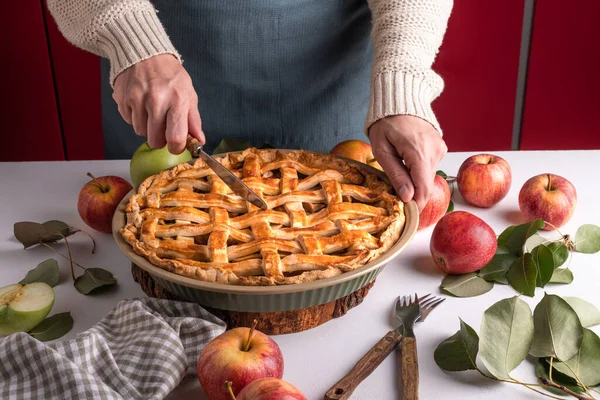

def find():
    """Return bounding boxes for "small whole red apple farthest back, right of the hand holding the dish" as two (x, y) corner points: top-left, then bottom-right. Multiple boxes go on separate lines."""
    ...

(456, 154), (512, 207)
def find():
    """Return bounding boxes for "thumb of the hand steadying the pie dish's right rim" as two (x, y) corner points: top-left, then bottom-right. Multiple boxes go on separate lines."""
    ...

(373, 139), (414, 203)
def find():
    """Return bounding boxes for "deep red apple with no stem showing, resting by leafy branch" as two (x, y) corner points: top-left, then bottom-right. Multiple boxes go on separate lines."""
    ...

(429, 211), (498, 274)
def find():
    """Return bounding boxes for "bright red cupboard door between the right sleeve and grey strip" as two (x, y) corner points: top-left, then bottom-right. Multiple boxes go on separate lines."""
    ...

(433, 0), (525, 151)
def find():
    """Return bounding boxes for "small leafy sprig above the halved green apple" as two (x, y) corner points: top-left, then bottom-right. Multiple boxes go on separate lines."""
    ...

(14, 220), (117, 294)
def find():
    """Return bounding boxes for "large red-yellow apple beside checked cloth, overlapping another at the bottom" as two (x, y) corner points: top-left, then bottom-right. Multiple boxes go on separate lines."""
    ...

(198, 327), (283, 400)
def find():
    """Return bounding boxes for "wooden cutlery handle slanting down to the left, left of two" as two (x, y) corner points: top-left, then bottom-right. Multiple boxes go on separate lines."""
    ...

(325, 331), (402, 400)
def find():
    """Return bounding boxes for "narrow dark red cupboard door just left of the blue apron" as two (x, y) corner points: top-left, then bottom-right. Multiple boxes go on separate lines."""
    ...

(44, 5), (104, 160)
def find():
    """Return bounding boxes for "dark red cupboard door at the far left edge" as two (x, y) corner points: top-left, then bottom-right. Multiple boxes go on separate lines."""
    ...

(0, 0), (65, 161)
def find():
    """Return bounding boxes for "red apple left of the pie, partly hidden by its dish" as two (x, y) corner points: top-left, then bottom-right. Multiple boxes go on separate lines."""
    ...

(77, 172), (133, 233)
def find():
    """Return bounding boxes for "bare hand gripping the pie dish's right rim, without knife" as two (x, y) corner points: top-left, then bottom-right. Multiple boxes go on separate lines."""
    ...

(369, 115), (448, 211)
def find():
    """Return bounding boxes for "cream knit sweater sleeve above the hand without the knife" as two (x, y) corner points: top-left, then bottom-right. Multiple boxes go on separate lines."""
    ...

(365, 0), (452, 134)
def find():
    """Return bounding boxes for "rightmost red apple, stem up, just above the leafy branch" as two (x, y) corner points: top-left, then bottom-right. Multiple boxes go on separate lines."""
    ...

(519, 174), (577, 230)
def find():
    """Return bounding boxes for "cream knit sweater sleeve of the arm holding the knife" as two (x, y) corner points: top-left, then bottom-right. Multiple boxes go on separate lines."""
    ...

(47, 0), (181, 84)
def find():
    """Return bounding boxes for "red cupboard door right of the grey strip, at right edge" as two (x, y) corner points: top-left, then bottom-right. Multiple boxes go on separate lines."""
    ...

(521, 0), (600, 150)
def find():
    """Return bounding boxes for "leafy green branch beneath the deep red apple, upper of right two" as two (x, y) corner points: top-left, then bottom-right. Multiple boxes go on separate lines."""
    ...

(441, 219), (600, 297)
